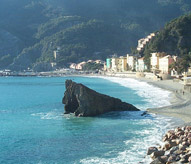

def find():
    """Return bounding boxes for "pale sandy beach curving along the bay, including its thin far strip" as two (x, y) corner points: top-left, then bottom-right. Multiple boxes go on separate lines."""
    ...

(85, 75), (191, 126)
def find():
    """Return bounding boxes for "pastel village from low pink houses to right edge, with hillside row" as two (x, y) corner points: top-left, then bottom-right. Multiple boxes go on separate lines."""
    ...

(70, 33), (191, 92)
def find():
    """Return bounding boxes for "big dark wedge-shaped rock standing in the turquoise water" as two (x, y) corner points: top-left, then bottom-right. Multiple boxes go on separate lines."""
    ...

(62, 80), (139, 117)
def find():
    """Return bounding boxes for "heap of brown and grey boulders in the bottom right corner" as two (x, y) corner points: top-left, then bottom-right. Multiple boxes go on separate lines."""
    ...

(147, 126), (191, 164)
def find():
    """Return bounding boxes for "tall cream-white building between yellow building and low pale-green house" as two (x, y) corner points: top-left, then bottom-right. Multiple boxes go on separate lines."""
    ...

(127, 54), (139, 71)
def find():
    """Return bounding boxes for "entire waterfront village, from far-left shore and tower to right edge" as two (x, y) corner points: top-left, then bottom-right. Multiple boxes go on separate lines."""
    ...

(0, 33), (191, 92)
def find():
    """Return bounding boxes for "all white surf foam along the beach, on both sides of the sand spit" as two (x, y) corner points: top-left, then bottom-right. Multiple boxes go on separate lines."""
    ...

(80, 77), (173, 164)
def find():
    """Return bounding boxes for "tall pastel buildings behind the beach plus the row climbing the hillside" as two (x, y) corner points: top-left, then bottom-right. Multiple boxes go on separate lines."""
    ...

(104, 33), (178, 80)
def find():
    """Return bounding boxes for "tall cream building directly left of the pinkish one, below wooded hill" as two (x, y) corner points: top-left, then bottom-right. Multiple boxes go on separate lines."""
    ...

(150, 52), (166, 72)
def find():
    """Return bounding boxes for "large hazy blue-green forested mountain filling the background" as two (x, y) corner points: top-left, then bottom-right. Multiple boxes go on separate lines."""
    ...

(0, 0), (191, 69)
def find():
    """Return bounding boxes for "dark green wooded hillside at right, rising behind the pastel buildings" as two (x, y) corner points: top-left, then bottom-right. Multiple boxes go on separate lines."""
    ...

(144, 14), (191, 66)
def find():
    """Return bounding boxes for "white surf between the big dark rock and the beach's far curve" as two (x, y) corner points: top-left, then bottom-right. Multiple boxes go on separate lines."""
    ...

(95, 77), (171, 110)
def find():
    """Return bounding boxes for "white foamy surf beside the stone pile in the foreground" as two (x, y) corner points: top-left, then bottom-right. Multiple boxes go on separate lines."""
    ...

(80, 116), (175, 164)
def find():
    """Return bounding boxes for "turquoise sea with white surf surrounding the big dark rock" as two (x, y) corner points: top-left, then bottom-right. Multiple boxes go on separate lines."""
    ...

(0, 76), (176, 164)
